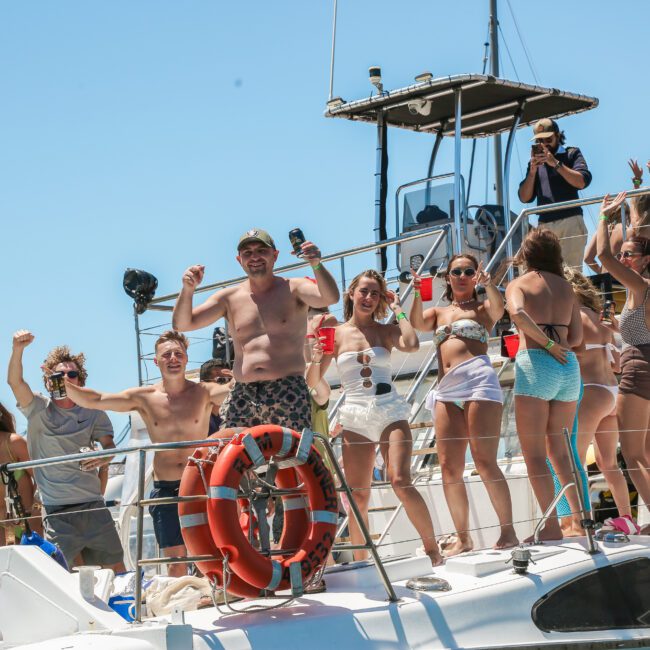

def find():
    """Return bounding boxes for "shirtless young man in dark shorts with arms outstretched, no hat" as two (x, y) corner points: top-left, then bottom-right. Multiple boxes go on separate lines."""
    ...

(66, 331), (228, 576)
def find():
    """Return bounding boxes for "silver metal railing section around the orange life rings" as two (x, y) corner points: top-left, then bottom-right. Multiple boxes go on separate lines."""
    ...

(0, 430), (398, 622)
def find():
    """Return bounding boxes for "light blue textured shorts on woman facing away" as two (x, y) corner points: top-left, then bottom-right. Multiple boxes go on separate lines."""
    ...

(515, 350), (580, 402)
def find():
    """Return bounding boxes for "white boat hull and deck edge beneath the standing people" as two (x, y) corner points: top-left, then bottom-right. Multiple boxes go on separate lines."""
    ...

(5, 537), (650, 650)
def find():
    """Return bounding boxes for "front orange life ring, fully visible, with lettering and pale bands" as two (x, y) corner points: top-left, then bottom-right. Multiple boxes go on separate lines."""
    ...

(207, 424), (338, 591)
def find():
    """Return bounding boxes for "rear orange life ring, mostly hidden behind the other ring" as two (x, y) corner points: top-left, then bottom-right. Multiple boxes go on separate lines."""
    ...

(178, 429), (260, 598)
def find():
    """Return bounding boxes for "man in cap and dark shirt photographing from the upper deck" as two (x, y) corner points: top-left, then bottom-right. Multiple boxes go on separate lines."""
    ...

(519, 118), (591, 271)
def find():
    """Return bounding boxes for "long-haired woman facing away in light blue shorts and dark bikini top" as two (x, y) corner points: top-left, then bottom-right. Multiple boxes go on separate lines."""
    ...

(506, 228), (582, 540)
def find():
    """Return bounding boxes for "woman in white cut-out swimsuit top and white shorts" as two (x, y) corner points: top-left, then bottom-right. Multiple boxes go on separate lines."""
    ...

(307, 270), (443, 566)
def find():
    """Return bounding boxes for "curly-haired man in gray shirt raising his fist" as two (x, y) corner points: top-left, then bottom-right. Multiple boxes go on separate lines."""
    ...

(8, 330), (125, 572)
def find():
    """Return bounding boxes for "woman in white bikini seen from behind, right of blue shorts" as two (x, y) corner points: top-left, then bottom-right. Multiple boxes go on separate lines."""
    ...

(565, 269), (638, 532)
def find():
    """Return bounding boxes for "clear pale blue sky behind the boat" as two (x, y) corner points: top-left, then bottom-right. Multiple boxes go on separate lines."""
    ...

(0, 0), (650, 436)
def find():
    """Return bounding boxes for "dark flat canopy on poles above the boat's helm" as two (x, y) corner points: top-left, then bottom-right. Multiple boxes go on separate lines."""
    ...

(325, 74), (598, 138)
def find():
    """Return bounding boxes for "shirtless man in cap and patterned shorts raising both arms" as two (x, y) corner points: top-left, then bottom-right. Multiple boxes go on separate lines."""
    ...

(172, 229), (339, 431)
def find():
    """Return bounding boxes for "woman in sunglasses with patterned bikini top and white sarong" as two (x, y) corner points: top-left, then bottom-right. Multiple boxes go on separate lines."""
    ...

(411, 255), (518, 557)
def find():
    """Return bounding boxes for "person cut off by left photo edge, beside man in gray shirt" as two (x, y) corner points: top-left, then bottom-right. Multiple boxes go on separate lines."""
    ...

(0, 404), (43, 546)
